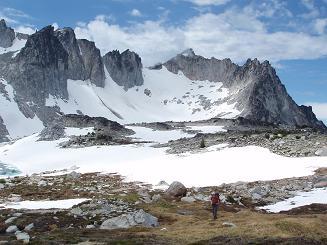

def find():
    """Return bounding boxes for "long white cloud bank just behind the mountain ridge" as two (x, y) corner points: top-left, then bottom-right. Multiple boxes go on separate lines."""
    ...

(75, 8), (327, 65)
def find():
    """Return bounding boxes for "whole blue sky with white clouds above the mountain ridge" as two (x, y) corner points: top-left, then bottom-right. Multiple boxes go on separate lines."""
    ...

(0, 0), (327, 122)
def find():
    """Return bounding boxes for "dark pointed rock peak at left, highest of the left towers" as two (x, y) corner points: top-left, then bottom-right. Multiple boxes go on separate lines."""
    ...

(2, 26), (68, 104)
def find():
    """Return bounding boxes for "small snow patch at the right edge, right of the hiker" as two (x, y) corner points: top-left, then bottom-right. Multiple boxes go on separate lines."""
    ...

(260, 188), (327, 213)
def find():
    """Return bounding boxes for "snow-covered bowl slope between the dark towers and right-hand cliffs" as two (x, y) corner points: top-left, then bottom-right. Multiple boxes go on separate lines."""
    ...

(46, 68), (240, 123)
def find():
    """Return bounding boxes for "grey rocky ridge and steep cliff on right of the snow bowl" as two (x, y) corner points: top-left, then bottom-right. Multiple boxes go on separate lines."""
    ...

(163, 50), (324, 128)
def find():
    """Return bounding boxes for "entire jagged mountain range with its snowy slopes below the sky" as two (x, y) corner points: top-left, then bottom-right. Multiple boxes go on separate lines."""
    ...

(0, 20), (325, 140)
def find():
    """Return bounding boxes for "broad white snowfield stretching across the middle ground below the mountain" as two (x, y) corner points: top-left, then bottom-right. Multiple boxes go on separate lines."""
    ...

(0, 127), (327, 187)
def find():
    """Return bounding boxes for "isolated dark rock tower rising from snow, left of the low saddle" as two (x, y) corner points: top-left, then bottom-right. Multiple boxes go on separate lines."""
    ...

(103, 50), (144, 90)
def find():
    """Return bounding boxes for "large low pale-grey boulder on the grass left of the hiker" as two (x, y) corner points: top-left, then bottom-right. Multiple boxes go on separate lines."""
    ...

(100, 209), (159, 230)
